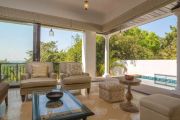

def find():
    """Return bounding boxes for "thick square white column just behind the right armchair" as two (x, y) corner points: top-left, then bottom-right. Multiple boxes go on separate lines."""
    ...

(82, 31), (96, 77)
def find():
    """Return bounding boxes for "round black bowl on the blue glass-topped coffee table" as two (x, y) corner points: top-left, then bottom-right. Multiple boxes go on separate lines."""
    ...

(46, 91), (63, 101)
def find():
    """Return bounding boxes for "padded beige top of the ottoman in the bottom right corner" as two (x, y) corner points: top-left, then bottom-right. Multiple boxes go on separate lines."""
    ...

(140, 94), (180, 118)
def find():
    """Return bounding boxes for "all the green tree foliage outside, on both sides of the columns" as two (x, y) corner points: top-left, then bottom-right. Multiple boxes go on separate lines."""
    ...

(24, 26), (177, 76)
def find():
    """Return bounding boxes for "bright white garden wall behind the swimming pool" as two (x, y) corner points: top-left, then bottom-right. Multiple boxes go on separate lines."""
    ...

(127, 60), (177, 76)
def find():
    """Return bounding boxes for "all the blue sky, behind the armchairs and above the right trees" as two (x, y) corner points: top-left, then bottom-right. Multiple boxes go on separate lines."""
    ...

(0, 16), (177, 61)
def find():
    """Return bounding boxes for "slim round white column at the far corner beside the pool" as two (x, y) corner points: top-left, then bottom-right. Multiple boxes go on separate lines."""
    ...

(103, 35), (110, 77)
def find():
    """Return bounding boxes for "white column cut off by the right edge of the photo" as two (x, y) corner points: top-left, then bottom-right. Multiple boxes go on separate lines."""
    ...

(174, 8), (180, 90)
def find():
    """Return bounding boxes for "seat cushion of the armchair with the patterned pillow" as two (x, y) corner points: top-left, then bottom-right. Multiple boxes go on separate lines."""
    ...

(61, 75), (91, 85)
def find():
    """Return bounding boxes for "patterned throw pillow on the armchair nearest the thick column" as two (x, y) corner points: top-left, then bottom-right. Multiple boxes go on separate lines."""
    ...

(67, 63), (82, 75)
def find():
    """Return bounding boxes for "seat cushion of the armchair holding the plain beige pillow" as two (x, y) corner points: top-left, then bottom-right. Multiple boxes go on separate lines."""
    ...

(20, 78), (57, 88)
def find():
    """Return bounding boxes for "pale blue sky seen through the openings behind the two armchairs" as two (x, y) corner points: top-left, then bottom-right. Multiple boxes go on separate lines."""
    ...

(0, 22), (83, 61)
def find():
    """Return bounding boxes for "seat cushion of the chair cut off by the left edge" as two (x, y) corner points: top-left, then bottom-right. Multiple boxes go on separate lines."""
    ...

(0, 82), (9, 101)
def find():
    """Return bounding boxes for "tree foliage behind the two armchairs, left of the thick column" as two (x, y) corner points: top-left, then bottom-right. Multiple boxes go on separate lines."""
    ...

(26, 35), (82, 63)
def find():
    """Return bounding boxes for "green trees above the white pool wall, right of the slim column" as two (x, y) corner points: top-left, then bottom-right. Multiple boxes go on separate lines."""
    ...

(105, 26), (177, 75)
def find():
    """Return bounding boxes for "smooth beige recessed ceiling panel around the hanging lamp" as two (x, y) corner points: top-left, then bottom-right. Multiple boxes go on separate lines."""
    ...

(0, 0), (146, 25)
